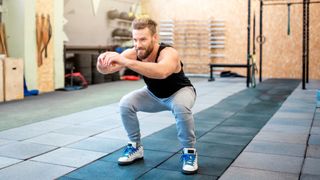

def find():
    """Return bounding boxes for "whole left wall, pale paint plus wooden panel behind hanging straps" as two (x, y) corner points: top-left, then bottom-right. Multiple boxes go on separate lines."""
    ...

(3, 0), (64, 93)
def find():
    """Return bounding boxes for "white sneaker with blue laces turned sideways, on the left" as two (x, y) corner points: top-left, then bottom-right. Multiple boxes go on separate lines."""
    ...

(118, 142), (143, 165)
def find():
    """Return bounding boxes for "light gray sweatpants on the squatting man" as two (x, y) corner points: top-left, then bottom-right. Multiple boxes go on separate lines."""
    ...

(120, 86), (196, 148)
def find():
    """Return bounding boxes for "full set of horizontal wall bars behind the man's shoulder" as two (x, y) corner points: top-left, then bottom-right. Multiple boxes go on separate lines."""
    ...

(159, 19), (225, 74)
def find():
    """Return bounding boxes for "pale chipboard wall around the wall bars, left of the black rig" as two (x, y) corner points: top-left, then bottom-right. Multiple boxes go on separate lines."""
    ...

(141, 0), (247, 74)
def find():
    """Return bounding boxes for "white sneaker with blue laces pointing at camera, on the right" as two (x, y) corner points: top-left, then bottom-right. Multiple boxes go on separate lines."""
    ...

(181, 148), (198, 174)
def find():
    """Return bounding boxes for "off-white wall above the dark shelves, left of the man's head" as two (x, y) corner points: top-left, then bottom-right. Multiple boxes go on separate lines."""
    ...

(64, 0), (138, 46)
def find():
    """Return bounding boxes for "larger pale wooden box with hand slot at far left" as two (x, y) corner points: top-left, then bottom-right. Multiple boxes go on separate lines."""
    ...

(3, 58), (24, 101)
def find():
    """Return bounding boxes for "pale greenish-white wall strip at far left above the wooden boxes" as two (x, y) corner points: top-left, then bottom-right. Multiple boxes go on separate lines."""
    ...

(3, 0), (37, 89)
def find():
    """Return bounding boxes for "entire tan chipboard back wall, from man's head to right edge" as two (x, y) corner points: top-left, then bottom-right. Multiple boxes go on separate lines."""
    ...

(141, 0), (320, 79)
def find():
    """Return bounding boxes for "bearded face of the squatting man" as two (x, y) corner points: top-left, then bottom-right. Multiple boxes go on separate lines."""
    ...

(132, 28), (155, 59)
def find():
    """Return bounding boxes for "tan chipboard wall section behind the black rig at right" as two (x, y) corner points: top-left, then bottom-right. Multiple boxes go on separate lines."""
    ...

(256, 1), (320, 79)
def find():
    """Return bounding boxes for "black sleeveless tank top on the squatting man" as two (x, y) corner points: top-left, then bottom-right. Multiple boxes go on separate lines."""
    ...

(138, 43), (192, 98)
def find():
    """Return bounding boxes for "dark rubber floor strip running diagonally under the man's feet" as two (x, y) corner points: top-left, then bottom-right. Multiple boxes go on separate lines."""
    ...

(59, 79), (299, 179)
